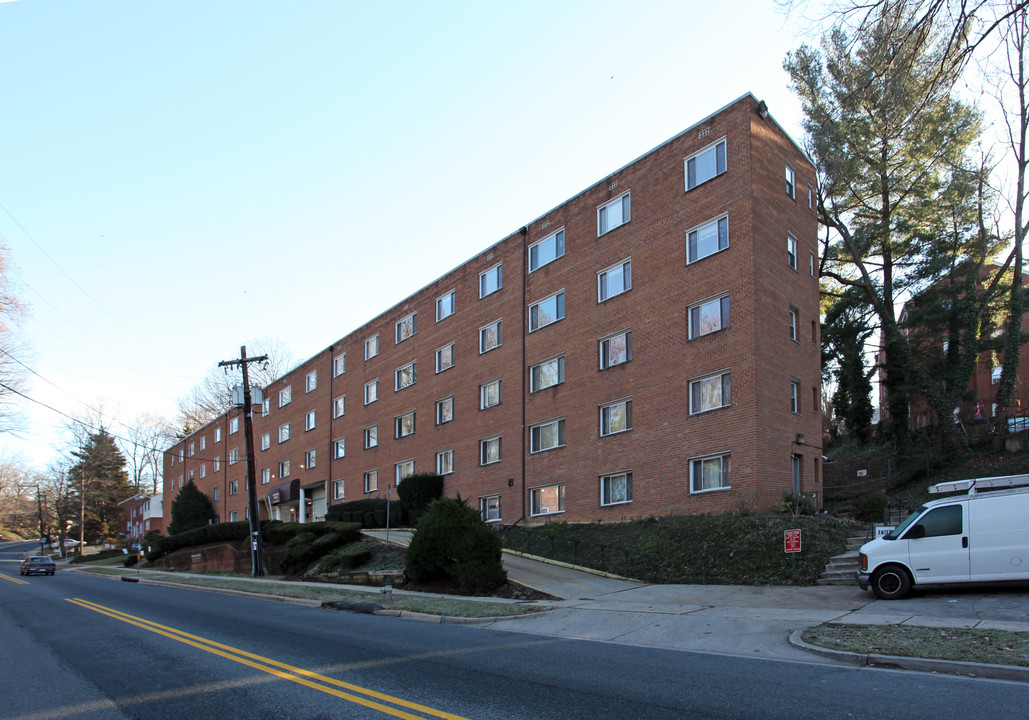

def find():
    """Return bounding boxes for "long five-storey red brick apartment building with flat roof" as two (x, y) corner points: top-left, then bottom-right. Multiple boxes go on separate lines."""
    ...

(165, 94), (822, 524)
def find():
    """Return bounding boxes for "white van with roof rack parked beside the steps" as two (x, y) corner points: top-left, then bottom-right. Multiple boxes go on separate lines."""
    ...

(857, 474), (1029, 600)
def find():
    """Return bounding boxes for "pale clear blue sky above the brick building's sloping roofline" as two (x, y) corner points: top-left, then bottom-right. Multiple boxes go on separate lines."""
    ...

(0, 0), (812, 467)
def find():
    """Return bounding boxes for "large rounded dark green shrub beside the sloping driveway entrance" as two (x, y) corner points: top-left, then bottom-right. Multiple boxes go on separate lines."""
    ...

(404, 495), (507, 590)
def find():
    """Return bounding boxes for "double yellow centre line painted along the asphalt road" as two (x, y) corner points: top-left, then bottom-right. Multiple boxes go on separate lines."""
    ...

(68, 596), (473, 720)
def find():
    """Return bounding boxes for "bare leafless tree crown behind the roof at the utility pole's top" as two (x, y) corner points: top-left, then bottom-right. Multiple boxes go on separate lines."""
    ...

(175, 337), (296, 436)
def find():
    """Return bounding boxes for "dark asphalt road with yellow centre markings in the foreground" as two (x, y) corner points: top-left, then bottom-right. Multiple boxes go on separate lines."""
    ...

(0, 544), (1029, 720)
